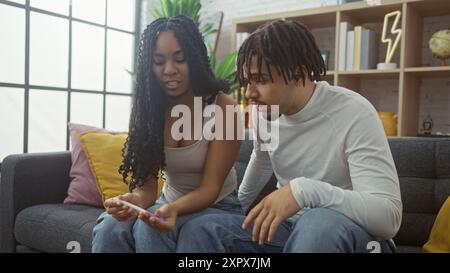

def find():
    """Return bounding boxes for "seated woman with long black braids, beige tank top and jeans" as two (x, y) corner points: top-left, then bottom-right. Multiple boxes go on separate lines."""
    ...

(92, 16), (241, 252)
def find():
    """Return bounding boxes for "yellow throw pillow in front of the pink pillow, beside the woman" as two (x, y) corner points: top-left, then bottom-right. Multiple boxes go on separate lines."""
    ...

(80, 132), (163, 205)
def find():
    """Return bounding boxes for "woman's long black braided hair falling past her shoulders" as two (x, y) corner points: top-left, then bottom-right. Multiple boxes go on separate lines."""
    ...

(119, 15), (229, 191)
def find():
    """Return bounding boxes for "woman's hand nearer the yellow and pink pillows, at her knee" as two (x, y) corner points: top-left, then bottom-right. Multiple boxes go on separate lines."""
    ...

(105, 193), (140, 221)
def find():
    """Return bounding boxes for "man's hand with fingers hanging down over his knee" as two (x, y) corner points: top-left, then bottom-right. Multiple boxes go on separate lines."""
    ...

(242, 184), (300, 245)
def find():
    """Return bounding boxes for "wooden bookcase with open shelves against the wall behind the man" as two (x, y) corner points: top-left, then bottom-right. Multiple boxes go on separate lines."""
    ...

(231, 0), (450, 137)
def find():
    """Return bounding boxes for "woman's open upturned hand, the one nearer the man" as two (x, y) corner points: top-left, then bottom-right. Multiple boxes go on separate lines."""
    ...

(138, 204), (178, 233)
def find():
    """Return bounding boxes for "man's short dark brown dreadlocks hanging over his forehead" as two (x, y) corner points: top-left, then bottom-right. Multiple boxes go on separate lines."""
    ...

(236, 20), (326, 86)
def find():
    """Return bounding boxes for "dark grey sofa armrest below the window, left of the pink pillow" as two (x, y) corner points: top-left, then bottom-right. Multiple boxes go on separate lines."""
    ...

(0, 152), (71, 252)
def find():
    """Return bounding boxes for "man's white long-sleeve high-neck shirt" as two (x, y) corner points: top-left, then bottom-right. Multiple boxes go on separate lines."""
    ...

(239, 82), (402, 239)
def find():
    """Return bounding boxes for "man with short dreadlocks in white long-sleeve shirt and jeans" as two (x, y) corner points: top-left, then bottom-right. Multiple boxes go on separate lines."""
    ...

(179, 20), (402, 252)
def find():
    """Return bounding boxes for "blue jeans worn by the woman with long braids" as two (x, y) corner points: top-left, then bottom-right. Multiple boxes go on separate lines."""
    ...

(92, 192), (242, 253)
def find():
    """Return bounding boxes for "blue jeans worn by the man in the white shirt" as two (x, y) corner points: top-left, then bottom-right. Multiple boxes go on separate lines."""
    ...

(177, 208), (391, 253)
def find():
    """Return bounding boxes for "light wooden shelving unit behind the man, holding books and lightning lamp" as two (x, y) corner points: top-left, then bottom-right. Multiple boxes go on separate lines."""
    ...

(231, 0), (450, 136)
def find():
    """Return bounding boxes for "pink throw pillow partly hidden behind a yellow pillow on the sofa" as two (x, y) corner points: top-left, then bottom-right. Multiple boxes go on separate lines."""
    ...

(64, 122), (113, 207)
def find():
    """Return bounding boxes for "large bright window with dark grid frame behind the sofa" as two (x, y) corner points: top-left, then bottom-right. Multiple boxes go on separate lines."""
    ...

(0, 0), (141, 162)
